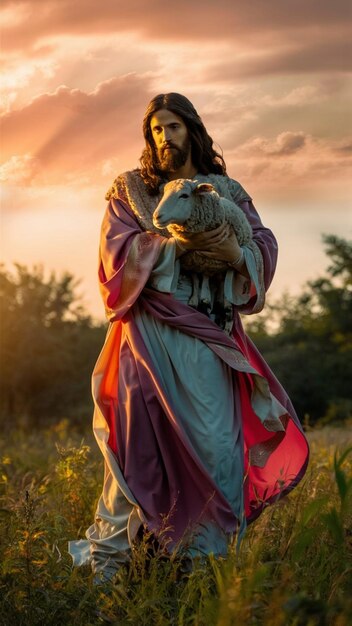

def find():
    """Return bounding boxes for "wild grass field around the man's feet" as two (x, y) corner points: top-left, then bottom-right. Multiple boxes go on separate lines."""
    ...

(0, 421), (352, 626)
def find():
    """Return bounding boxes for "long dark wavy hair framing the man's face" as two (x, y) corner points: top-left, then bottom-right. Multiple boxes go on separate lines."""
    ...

(140, 93), (226, 195)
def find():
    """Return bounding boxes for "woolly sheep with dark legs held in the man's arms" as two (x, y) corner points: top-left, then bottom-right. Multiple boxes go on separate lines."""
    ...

(153, 179), (252, 327)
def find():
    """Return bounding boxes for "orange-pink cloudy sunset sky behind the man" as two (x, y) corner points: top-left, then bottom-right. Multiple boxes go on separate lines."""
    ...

(0, 0), (352, 319)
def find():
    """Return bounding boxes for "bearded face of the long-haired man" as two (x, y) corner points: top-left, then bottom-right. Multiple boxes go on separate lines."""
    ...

(150, 109), (191, 172)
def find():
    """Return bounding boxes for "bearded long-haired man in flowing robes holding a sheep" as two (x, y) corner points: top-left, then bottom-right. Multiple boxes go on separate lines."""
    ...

(70, 93), (308, 576)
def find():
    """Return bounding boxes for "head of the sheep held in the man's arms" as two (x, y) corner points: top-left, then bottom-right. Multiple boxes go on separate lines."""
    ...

(153, 178), (217, 228)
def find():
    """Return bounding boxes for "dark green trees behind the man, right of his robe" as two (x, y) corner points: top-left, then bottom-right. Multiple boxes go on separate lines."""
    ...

(246, 235), (352, 424)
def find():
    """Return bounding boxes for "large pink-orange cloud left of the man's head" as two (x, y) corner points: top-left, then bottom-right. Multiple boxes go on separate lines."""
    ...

(2, 75), (151, 184)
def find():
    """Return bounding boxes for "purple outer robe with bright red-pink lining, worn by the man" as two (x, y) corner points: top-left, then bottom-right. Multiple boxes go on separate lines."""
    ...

(89, 184), (308, 545)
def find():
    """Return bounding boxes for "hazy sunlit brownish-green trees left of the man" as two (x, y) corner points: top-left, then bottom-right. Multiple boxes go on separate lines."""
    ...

(0, 264), (104, 426)
